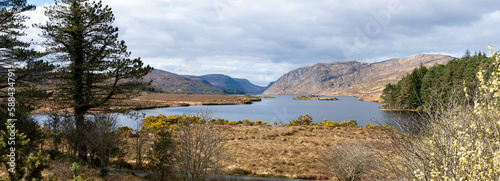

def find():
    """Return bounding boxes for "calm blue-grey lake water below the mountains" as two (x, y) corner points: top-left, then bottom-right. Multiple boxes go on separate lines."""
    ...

(35, 95), (398, 127)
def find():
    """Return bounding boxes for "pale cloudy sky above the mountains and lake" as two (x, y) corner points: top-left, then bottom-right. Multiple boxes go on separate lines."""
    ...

(26, 0), (500, 86)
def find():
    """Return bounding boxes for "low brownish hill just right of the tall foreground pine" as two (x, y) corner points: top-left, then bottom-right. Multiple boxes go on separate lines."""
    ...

(144, 70), (224, 94)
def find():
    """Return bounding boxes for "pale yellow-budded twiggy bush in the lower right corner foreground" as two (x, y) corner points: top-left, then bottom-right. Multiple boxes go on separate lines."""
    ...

(384, 47), (500, 180)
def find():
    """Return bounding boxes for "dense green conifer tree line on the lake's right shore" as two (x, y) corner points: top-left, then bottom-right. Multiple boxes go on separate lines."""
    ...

(381, 50), (493, 110)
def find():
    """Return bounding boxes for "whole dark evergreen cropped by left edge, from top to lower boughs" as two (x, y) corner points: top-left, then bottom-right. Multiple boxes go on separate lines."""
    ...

(0, 0), (53, 146)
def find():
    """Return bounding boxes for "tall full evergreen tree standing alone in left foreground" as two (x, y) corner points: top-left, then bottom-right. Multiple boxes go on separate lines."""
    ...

(38, 0), (152, 159)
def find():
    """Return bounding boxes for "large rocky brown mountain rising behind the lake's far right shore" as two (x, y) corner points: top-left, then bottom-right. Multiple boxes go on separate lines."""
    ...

(263, 54), (454, 99)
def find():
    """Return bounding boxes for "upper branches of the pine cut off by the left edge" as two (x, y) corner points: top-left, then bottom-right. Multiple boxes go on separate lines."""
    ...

(0, 0), (53, 95)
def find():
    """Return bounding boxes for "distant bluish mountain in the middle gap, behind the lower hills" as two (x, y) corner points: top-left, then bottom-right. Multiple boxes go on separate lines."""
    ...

(200, 74), (266, 94)
